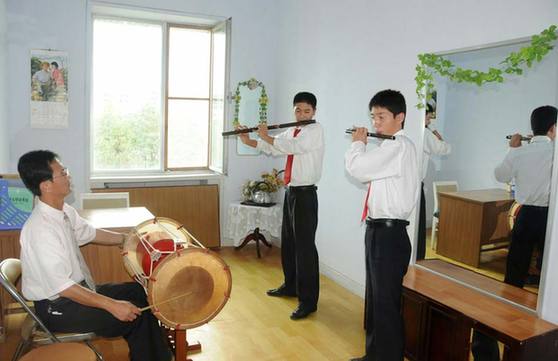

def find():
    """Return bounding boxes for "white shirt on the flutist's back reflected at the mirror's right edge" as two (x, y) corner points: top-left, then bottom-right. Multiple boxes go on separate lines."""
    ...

(494, 135), (554, 207)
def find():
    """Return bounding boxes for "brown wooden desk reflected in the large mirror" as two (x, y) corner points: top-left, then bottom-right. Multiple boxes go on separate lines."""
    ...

(436, 189), (513, 267)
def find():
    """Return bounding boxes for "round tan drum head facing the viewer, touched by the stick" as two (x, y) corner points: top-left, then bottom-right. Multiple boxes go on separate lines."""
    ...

(147, 248), (232, 329)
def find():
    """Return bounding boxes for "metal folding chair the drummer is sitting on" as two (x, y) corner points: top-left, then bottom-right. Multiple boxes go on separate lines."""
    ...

(0, 258), (103, 361)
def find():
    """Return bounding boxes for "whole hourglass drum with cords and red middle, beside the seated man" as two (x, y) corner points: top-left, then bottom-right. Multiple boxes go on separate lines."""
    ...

(122, 217), (232, 329)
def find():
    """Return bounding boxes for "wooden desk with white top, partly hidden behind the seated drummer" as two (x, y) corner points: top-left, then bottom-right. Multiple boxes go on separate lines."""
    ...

(0, 207), (154, 342)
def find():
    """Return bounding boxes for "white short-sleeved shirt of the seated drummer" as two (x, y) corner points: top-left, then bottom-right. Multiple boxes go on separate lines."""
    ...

(20, 199), (96, 301)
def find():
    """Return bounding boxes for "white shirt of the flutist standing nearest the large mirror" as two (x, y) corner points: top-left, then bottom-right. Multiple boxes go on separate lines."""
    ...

(345, 130), (419, 219)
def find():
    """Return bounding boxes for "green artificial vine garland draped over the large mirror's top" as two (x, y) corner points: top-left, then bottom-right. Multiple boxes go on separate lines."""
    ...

(415, 25), (557, 109)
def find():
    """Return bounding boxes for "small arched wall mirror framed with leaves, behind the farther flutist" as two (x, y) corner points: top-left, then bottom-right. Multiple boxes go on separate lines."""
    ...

(233, 78), (268, 155)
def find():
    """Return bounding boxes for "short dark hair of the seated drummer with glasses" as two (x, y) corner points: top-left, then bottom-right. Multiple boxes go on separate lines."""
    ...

(17, 150), (58, 196)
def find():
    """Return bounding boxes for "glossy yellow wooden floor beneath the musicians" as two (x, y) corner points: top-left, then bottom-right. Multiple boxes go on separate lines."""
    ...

(0, 245), (376, 361)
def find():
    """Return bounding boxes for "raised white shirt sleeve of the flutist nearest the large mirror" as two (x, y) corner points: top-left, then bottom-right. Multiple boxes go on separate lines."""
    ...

(345, 140), (404, 182)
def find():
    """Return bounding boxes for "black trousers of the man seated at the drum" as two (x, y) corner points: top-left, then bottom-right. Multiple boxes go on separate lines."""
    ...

(35, 282), (172, 361)
